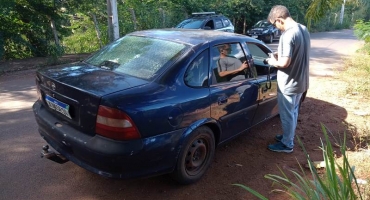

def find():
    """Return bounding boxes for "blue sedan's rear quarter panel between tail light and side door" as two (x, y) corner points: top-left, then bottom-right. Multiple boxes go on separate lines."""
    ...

(101, 44), (210, 138)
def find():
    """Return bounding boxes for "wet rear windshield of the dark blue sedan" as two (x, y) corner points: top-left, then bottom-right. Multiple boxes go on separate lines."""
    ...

(86, 36), (187, 79)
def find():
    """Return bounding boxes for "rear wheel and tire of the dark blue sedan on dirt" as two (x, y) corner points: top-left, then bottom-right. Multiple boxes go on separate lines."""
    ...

(171, 126), (216, 184)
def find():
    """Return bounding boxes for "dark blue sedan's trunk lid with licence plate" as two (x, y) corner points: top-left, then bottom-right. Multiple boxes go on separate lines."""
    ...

(36, 63), (148, 135)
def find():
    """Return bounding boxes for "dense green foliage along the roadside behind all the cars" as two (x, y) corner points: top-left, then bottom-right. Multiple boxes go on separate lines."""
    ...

(0, 0), (370, 60)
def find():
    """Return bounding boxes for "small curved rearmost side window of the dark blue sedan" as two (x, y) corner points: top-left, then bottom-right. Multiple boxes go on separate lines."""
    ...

(184, 50), (209, 87)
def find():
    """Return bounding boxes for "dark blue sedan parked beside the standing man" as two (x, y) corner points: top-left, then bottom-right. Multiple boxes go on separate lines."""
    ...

(33, 29), (278, 184)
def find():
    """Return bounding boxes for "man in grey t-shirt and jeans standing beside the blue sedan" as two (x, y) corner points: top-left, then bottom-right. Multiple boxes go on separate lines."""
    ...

(267, 5), (311, 153)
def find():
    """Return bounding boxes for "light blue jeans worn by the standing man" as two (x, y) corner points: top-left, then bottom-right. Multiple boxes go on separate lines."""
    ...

(277, 90), (302, 148)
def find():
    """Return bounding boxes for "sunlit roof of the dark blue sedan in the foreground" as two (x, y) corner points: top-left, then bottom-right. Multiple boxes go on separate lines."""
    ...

(128, 28), (259, 46)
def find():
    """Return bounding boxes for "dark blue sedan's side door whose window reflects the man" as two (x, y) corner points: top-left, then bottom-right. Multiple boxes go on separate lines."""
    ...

(210, 43), (258, 141)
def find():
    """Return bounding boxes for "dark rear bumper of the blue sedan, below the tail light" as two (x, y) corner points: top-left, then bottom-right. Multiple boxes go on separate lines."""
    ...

(33, 101), (184, 179)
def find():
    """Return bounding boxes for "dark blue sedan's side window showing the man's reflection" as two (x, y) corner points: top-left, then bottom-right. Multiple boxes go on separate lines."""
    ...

(211, 43), (248, 84)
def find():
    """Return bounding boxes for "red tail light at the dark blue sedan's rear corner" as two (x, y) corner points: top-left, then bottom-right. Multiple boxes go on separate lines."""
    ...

(95, 106), (141, 140)
